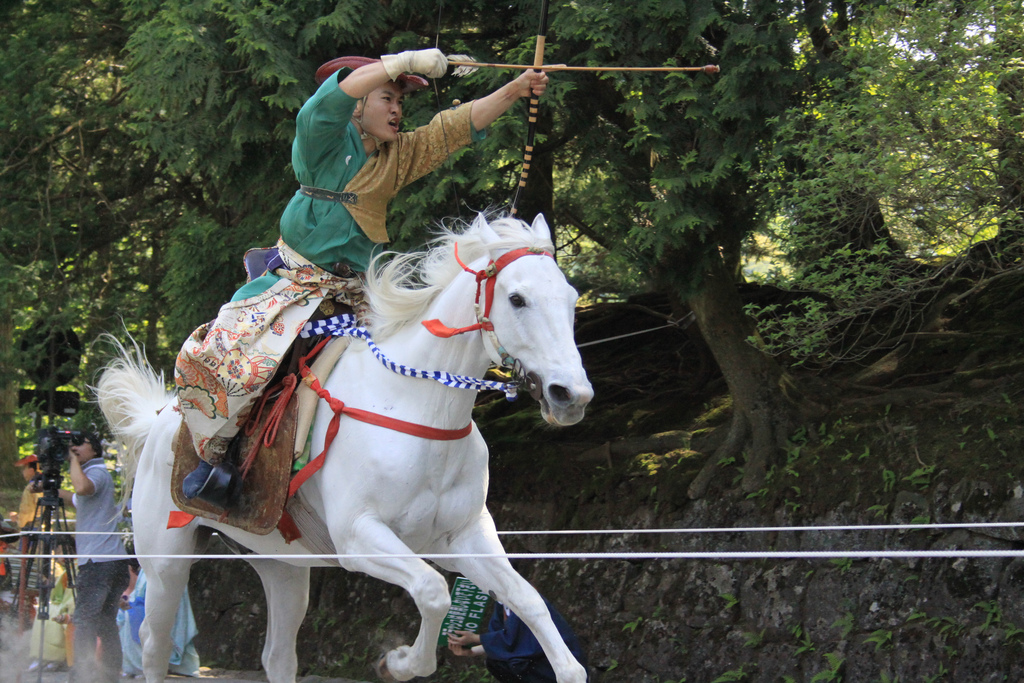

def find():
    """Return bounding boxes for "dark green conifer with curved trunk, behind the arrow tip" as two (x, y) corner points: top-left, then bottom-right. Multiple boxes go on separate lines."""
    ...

(554, 1), (813, 497)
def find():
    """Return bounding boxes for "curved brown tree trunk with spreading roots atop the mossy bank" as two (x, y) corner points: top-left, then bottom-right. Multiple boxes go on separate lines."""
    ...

(687, 254), (803, 499)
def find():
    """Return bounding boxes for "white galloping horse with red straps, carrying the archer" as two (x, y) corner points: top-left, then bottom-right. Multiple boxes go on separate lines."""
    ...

(96, 216), (593, 683)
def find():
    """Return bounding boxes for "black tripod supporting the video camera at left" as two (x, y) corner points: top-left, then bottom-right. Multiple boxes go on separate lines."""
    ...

(16, 480), (76, 681)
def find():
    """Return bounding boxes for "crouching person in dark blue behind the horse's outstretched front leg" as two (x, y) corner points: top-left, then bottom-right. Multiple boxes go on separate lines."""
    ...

(449, 596), (589, 683)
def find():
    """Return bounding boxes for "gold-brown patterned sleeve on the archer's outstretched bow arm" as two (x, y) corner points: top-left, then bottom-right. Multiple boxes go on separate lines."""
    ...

(395, 102), (473, 190)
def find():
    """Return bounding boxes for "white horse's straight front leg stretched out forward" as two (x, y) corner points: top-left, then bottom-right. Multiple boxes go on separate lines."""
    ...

(437, 511), (587, 683)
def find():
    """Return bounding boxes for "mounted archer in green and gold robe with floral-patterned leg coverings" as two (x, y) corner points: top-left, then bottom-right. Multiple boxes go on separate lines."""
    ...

(174, 49), (548, 509)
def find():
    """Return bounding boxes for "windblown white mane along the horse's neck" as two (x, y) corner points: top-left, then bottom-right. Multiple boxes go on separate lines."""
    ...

(366, 214), (554, 340)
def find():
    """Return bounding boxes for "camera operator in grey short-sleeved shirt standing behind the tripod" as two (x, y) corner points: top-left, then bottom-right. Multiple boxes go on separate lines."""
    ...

(51, 432), (129, 683)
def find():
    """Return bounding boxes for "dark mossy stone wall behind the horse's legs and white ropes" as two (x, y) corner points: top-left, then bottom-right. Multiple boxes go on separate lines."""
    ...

(184, 476), (1024, 683)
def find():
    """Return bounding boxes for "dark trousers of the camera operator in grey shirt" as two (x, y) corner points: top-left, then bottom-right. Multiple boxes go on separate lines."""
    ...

(69, 560), (128, 683)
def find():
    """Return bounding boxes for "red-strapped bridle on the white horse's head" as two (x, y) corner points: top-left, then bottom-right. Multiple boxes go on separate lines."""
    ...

(423, 245), (554, 398)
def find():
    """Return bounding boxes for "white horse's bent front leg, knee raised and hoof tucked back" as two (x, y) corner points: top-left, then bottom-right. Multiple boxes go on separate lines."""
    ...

(333, 518), (452, 681)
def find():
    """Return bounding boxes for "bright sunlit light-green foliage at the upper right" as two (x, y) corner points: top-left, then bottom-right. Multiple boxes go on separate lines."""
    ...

(749, 0), (1024, 368)
